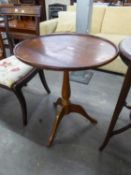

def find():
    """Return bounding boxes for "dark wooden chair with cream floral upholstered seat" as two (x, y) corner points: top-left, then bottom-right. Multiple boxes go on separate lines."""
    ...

(0, 33), (50, 125)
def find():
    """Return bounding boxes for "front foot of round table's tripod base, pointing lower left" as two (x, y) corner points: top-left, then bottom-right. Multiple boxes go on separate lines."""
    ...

(47, 107), (65, 146)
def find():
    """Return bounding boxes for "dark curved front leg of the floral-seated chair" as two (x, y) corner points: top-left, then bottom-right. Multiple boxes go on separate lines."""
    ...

(13, 87), (27, 126)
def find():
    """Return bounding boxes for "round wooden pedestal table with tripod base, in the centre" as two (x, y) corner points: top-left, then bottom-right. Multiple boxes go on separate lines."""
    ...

(14, 34), (118, 146)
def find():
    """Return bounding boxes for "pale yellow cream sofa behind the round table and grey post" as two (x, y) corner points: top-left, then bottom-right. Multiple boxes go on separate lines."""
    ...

(40, 5), (131, 74)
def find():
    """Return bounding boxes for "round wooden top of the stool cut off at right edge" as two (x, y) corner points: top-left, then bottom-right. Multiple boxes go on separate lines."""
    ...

(119, 37), (131, 65)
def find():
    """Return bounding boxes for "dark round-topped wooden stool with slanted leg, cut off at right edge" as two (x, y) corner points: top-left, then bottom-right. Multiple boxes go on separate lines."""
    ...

(100, 37), (131, 151)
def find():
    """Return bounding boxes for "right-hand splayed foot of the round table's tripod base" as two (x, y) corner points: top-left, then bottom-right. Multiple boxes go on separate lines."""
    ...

(70, 104), (97, 124)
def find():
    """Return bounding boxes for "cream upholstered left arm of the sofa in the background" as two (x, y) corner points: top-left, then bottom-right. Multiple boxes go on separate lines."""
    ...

(40, 18), (58, 35)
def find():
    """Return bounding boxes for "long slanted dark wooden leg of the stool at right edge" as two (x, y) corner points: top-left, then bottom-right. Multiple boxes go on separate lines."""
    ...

(100, 67), (131, 151)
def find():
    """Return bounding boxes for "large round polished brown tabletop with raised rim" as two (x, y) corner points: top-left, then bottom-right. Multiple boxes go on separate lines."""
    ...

(14, 34), (118, 71)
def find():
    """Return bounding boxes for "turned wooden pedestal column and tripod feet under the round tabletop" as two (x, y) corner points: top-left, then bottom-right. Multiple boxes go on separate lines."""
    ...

(48, 71), (97, 146)
